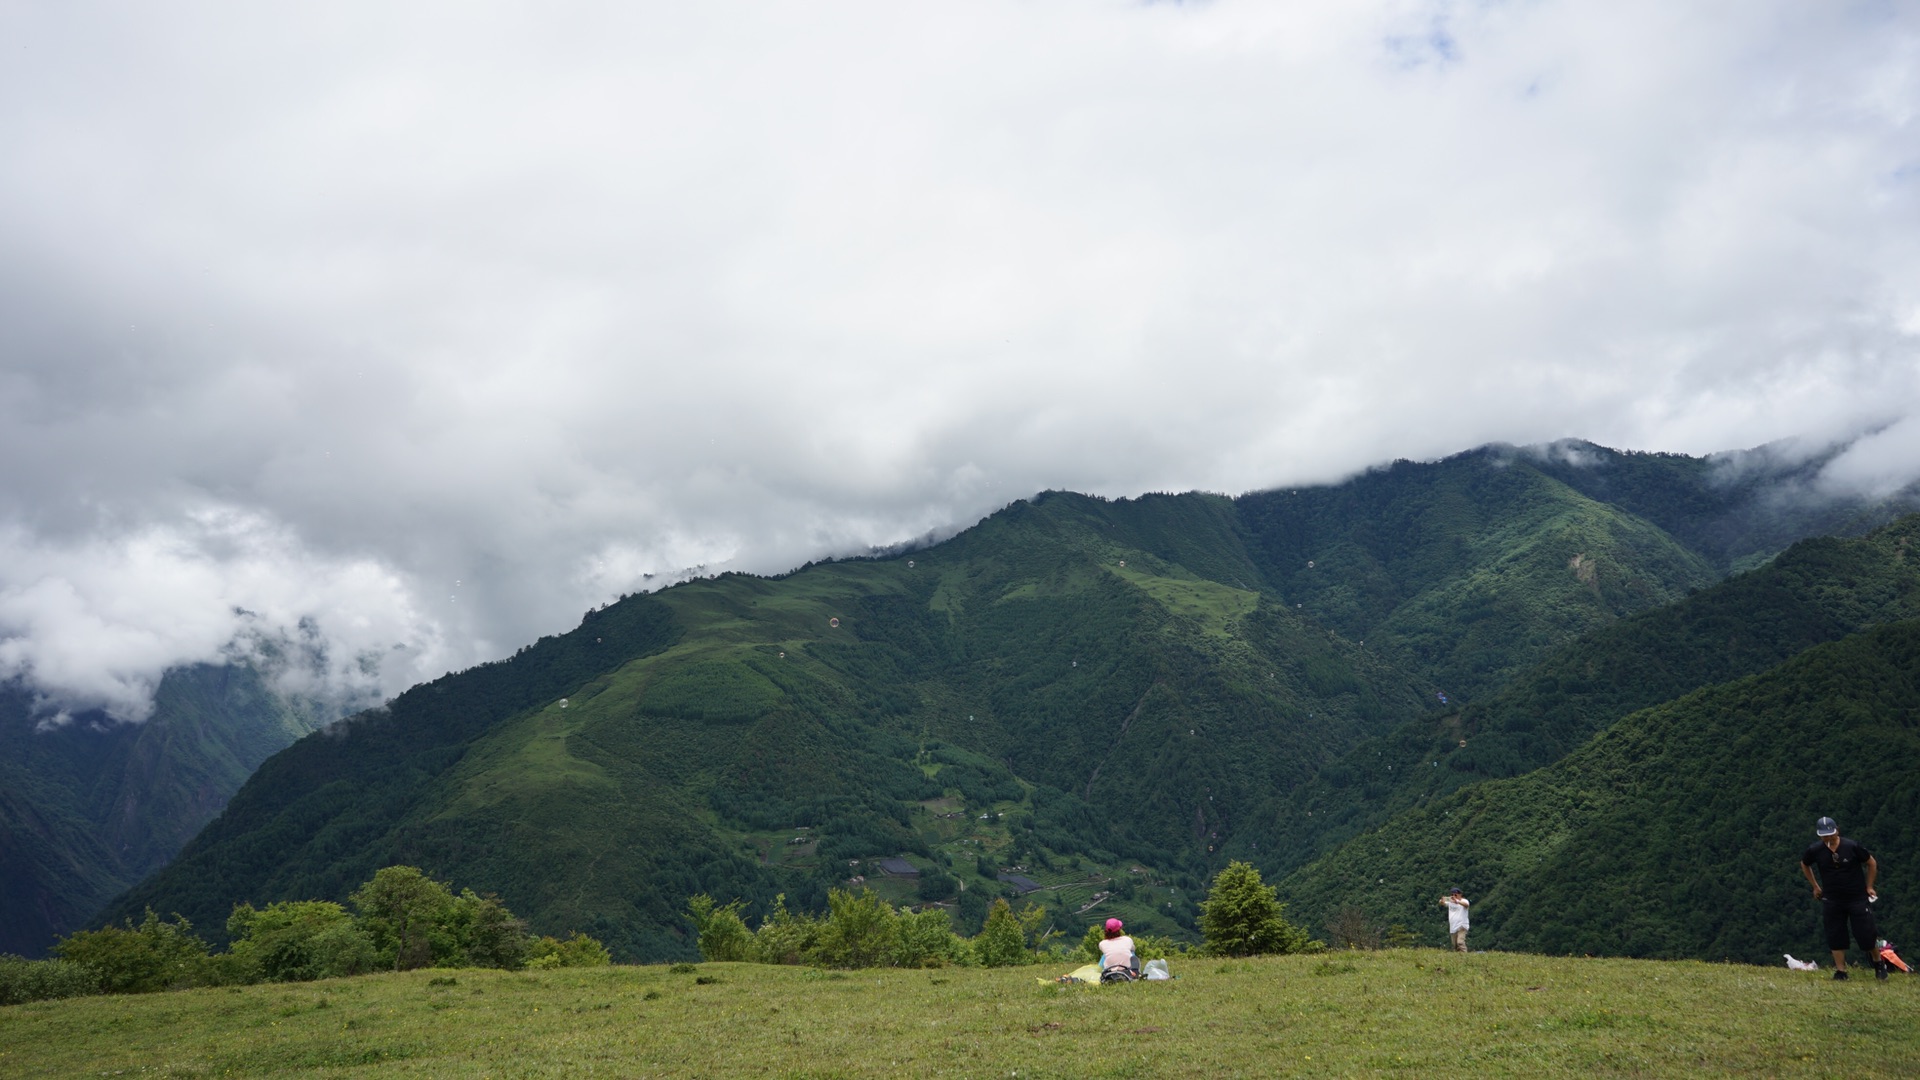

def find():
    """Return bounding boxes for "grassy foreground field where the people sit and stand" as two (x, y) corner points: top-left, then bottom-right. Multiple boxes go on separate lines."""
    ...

(0, 949), (1920, 1078)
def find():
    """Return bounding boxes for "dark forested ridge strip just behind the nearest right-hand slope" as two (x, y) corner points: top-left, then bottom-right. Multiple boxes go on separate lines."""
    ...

(1236, 515), (1920, 876)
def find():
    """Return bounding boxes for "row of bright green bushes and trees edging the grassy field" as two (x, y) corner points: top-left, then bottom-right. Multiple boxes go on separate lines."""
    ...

(0, 863), (1323, 1005)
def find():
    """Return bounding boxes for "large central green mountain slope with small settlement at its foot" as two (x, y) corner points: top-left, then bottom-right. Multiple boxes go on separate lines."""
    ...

(115, 496), (1428, 955)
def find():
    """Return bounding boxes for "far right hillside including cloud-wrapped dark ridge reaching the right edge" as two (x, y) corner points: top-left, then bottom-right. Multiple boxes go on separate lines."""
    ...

(1236, 440), (1920, 701)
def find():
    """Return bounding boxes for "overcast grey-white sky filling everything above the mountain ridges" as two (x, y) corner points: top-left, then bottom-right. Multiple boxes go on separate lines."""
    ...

(0, 0), (1920, 719)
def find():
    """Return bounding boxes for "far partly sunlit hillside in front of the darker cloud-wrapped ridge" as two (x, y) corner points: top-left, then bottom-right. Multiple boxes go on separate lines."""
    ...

(1240, 452), (1718, 700)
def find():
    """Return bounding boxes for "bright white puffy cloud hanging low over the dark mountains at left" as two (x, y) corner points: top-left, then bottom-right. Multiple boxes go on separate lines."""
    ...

(0, 507), (447, 721)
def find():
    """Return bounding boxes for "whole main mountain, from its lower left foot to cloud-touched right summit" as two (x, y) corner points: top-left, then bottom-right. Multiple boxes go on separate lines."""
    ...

(82, 444), (1912, 959)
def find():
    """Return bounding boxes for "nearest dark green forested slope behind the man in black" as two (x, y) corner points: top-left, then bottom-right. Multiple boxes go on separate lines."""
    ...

(1281, 621), (1920, 963)
